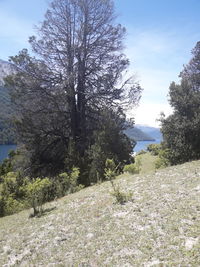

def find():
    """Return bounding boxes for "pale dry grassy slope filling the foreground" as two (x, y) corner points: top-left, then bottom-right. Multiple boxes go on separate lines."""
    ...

(0, 161), (200, 267)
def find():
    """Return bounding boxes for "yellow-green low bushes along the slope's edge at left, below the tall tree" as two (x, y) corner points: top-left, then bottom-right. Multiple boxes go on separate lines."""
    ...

(0, 168), (83, 217)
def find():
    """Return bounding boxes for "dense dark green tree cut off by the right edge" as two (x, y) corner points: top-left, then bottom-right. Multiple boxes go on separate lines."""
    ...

(161, 42), (200, 164)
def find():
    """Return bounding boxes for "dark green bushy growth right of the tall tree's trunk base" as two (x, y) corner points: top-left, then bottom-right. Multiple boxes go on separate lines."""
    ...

(89, 110), (133, 185)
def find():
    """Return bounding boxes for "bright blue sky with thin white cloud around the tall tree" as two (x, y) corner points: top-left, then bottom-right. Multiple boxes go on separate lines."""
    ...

(0, 0), (200, 126)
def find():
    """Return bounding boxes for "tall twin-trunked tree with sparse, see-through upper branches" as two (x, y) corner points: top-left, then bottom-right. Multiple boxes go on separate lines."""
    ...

(7, 0), (141, 183)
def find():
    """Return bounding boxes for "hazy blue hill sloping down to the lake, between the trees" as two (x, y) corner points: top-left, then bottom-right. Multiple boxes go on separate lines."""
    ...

(124, 127), (155, 141)
